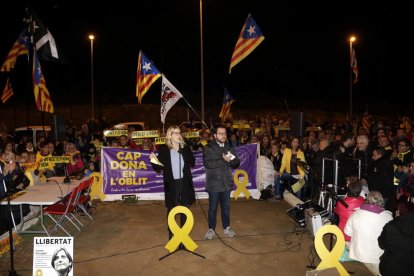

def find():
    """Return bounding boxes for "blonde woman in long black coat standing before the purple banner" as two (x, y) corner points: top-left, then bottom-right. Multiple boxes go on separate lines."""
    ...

(150, 125), (195, 239)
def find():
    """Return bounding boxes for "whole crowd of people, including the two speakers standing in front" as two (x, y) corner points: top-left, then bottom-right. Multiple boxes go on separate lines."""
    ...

(0, 115), (414, 275)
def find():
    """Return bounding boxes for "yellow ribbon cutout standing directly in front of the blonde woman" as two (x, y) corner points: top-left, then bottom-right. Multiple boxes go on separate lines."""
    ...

(165, 206), (198, 253)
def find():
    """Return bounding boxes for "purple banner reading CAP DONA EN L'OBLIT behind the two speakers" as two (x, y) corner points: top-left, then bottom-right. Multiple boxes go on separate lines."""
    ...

(102, 144), (257, 195)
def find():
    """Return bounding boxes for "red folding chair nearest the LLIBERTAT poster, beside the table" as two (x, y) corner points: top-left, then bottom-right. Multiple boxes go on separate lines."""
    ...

(43, 186), (83, 236)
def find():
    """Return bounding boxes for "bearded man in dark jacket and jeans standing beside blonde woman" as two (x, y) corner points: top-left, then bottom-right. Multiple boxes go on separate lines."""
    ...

(203, 126), (240, 240)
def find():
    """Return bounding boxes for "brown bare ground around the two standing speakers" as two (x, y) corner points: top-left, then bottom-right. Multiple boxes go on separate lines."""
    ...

(0, 198), (371, 276)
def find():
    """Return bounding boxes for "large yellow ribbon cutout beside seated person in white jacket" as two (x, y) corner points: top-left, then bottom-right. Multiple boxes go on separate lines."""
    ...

(315, 225), (349, 276)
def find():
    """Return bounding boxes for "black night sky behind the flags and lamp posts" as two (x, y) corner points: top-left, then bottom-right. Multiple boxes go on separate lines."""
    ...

(0, 0), (414, 114)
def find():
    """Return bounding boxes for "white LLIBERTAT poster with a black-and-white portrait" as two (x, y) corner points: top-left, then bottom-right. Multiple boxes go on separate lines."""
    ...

(33, 237), (73, 276)
